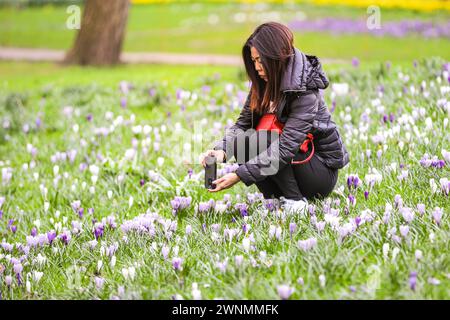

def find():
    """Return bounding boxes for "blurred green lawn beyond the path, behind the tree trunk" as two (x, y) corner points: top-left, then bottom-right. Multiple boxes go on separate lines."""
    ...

(0, 4), (450, 62)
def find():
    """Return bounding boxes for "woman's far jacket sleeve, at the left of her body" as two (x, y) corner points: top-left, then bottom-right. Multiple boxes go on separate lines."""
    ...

(214, 92), (252, 162)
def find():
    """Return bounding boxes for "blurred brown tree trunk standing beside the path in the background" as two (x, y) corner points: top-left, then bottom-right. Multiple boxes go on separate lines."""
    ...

(65, 0), (129, 65)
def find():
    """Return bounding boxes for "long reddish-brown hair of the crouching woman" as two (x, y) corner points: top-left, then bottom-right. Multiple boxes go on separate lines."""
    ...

(242, 22), (294, 114)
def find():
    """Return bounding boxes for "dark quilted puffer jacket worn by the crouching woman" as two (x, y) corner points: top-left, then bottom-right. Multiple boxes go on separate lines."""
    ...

(214, 48), (349, 186)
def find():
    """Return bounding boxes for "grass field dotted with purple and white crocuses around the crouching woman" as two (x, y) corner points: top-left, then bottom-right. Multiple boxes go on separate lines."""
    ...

(0, 55), (450, 299)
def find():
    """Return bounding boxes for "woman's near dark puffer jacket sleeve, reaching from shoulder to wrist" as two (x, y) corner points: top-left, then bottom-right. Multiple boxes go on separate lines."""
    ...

(236, 93), (319, 186)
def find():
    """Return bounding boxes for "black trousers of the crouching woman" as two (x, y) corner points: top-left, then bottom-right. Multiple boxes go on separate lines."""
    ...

(233, 131), (338, 200)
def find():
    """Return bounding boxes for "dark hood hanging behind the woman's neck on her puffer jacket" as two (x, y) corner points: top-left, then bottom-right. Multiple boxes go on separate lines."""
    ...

(280, 47), (329, 92)
